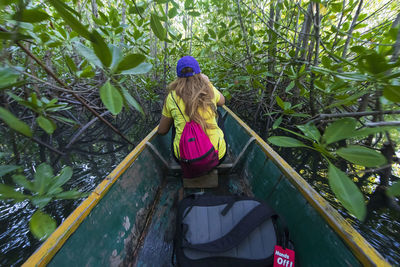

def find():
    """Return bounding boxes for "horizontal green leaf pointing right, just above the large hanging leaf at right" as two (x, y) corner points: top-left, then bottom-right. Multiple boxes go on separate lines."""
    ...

(336, 146), (387, 167)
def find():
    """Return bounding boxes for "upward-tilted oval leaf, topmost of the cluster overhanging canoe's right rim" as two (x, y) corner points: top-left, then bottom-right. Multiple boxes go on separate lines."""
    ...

(322, 118), (357, 145)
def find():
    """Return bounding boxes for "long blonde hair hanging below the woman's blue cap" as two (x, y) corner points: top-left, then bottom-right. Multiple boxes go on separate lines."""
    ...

(169, 68), (217, 130)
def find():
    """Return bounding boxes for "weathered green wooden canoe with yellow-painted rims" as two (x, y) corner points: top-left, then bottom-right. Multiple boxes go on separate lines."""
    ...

(24, 107), (390, 267)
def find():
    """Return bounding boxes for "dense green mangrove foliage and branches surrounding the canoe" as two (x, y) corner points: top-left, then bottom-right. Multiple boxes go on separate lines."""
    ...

(0, 0), (400, 266)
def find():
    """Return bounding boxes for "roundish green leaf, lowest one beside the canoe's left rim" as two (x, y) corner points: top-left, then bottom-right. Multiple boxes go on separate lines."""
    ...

(29, 210), (57, 241)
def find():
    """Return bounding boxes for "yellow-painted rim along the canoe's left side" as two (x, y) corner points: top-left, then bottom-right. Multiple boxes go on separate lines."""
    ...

(22, 127), (157, 267)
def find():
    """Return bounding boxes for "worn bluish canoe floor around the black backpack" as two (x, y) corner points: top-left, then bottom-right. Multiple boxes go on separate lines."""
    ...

(134, 170), (252, 266)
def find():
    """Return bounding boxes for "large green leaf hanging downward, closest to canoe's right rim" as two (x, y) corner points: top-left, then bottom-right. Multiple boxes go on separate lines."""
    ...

(328, 163), (367, 221)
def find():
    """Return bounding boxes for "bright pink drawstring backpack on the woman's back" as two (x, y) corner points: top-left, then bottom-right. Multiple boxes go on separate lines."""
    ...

(171, 94), (219, 178)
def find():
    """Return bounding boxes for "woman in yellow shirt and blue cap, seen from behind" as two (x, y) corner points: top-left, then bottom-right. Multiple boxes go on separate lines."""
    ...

(158, 56), (226, 170)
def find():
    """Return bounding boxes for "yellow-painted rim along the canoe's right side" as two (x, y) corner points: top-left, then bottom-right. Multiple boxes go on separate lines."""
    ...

(224, 106), (391, 267)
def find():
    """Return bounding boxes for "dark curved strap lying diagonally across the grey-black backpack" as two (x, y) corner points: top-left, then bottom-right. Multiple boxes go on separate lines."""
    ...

(182, 204), (275, 253)
